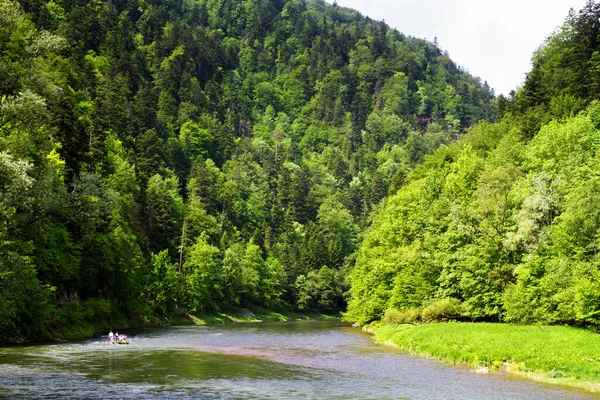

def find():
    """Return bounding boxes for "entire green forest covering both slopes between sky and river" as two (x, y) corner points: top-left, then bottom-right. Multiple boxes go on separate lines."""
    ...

(0, 0), (600, 340)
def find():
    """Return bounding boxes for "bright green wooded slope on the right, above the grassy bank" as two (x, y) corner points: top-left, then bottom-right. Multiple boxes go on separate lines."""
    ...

(347, 1), (600, 327)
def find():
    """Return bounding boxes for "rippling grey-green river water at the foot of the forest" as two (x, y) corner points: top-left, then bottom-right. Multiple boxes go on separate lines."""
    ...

(0, 321), (595, 399)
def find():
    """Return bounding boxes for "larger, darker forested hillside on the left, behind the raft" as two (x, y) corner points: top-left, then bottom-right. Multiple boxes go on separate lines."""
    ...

(0, 0), (496, 340)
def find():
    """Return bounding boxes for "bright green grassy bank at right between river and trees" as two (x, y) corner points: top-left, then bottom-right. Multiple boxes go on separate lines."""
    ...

(369, 322), (600, 392)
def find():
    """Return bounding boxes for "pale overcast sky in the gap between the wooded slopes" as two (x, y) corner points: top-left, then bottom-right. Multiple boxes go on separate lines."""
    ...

(328, 0), (585, 95)
